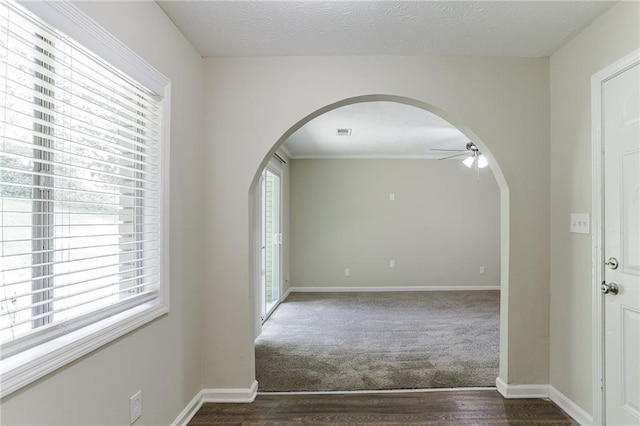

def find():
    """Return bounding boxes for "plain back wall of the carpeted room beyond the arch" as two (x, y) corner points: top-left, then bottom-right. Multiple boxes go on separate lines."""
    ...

(291, 159), (500, 287)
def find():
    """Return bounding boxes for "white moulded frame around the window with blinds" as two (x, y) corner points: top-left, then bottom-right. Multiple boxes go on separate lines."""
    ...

(0, 1), (171, 398)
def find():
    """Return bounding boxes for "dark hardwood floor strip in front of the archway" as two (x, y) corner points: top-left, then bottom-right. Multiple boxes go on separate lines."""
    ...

(189, 390), (578, 426)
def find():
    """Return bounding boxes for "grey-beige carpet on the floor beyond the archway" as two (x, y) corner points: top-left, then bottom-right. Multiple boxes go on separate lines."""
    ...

(256, 291), (500, 392)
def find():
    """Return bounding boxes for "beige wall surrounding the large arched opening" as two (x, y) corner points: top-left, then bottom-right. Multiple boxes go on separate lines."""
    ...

(202, 56), (549, 388)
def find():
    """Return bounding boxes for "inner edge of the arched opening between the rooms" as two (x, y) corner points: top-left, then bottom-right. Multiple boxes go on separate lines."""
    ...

(250, 95), (509, 392)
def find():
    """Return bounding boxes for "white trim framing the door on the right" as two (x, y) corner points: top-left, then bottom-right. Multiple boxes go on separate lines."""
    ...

(591, 49), (640, 425)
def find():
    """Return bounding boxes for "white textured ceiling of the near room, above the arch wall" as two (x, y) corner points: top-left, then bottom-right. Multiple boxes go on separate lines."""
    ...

(158, 0), (614, 57)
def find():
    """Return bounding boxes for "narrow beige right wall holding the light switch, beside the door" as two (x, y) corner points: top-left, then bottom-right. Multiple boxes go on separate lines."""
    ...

(550, 2), (640, 413)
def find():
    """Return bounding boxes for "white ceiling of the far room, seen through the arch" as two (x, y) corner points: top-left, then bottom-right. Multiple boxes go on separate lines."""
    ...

(285, 102), (469, 158)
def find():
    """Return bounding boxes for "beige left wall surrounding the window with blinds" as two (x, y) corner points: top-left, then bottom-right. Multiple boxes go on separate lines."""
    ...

(0, 2), (204, 425)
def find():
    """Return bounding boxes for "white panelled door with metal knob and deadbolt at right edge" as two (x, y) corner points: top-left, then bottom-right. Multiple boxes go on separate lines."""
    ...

(602, 59), (640, 426)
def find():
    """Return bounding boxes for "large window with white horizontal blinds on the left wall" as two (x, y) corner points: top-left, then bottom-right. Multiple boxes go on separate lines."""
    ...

(0, 1), (169, 396)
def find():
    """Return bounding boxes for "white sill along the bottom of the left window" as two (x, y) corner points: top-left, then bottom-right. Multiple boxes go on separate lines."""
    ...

(0, 300), (169, 398)
